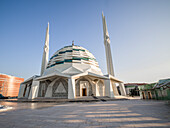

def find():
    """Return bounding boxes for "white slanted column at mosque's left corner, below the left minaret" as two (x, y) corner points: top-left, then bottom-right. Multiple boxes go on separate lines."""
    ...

(28, 80), (40, 99)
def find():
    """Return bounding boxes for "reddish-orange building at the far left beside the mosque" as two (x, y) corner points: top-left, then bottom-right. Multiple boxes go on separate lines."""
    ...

(0, 73), (24, 97)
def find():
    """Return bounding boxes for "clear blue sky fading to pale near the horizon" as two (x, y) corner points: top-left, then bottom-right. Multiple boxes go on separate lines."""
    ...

(0, 0), (170, 82)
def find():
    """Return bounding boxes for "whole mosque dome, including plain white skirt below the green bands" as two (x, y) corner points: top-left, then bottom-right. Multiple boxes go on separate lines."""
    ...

(43, 45), (102, 75)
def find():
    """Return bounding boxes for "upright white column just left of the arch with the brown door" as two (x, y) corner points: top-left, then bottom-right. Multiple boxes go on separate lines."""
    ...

(68, 78), (75, 99)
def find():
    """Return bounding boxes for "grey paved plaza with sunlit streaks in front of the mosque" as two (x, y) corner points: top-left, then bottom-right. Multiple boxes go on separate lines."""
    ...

(0, 100), (170, 128)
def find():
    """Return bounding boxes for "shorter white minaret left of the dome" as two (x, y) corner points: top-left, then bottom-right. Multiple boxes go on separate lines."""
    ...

(41, 22), (49, 75)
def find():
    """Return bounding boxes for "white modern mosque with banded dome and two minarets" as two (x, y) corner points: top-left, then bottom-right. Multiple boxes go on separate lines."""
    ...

(18, 14), (126, 99)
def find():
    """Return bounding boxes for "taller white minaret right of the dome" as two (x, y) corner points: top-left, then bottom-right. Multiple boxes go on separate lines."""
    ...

(102, 12), (114, 76)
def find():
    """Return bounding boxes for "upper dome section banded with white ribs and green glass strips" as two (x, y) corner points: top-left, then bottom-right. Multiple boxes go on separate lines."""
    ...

(47, 45), (99, 68)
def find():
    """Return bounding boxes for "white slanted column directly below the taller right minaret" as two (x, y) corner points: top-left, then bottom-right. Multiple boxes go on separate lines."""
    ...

(104, 79), (114, 98)
